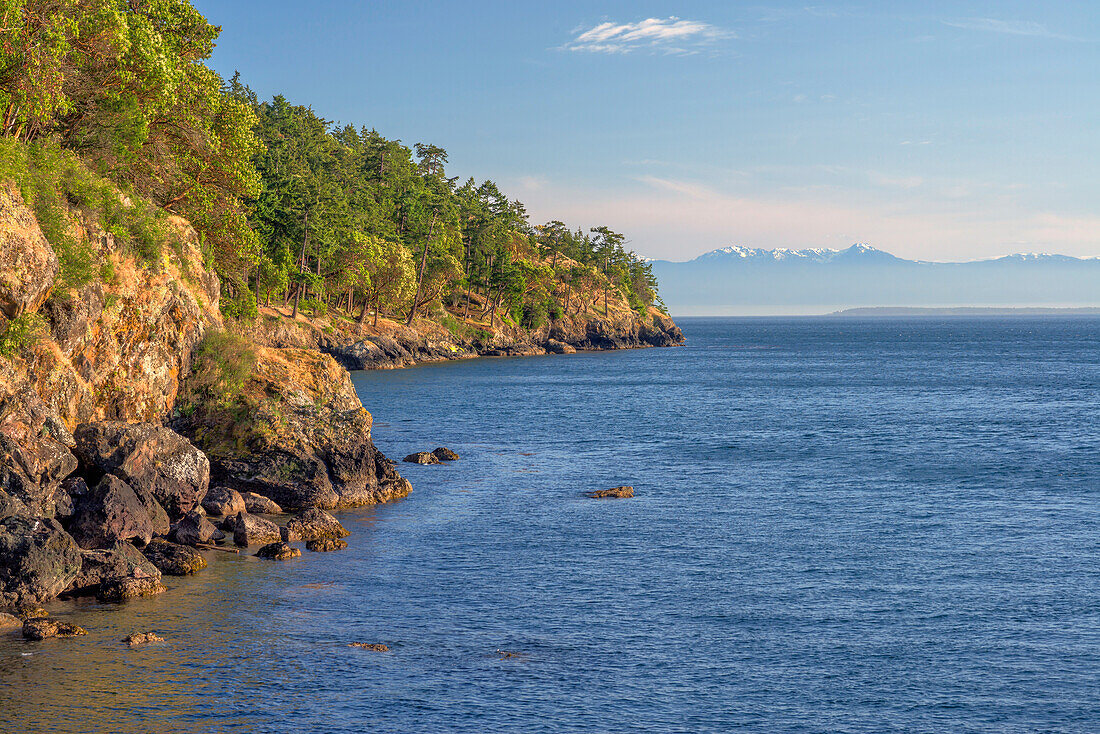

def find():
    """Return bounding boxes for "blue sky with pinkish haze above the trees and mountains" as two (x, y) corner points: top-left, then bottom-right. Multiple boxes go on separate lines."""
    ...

(195, 0), (1100, 260)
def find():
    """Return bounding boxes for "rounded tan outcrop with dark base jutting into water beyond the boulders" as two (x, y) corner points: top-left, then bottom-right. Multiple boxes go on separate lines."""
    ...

(175, 348), (411, 510)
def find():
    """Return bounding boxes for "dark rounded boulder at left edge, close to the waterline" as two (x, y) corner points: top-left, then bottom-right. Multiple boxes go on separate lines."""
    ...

(0, 516), (83, 606)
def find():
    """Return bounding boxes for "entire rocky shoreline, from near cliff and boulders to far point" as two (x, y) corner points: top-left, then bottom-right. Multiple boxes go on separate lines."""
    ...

(0, 170), (683, 616)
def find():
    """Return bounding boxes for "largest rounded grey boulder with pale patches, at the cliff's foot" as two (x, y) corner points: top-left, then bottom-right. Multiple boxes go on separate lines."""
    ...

(73, 420), (210, 519)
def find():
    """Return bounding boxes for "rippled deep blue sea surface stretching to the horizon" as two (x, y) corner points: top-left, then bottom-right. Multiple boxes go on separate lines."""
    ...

(0, 318), (1100, 734)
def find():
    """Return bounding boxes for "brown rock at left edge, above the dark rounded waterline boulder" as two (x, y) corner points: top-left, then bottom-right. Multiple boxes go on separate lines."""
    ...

(0, 434), (77, 517)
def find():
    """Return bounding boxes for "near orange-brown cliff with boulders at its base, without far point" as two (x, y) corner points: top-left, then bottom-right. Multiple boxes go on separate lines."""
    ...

(0, 178), (410, 606)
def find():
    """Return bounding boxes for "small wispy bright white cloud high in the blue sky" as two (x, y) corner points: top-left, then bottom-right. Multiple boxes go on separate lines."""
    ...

(562, 15), (735, 54)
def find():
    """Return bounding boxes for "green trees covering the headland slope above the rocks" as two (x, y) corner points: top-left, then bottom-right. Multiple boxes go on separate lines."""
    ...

(0, 0), (663, 338)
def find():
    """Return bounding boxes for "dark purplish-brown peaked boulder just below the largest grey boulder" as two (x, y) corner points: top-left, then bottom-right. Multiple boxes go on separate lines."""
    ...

(68, 474), (153, 548)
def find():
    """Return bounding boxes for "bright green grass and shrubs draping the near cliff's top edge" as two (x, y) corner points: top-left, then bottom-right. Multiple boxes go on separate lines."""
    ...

(0, 138), (174, 293)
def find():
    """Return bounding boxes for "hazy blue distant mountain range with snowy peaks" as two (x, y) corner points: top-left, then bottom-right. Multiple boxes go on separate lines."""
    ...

(652, 244), (1100, 316)
